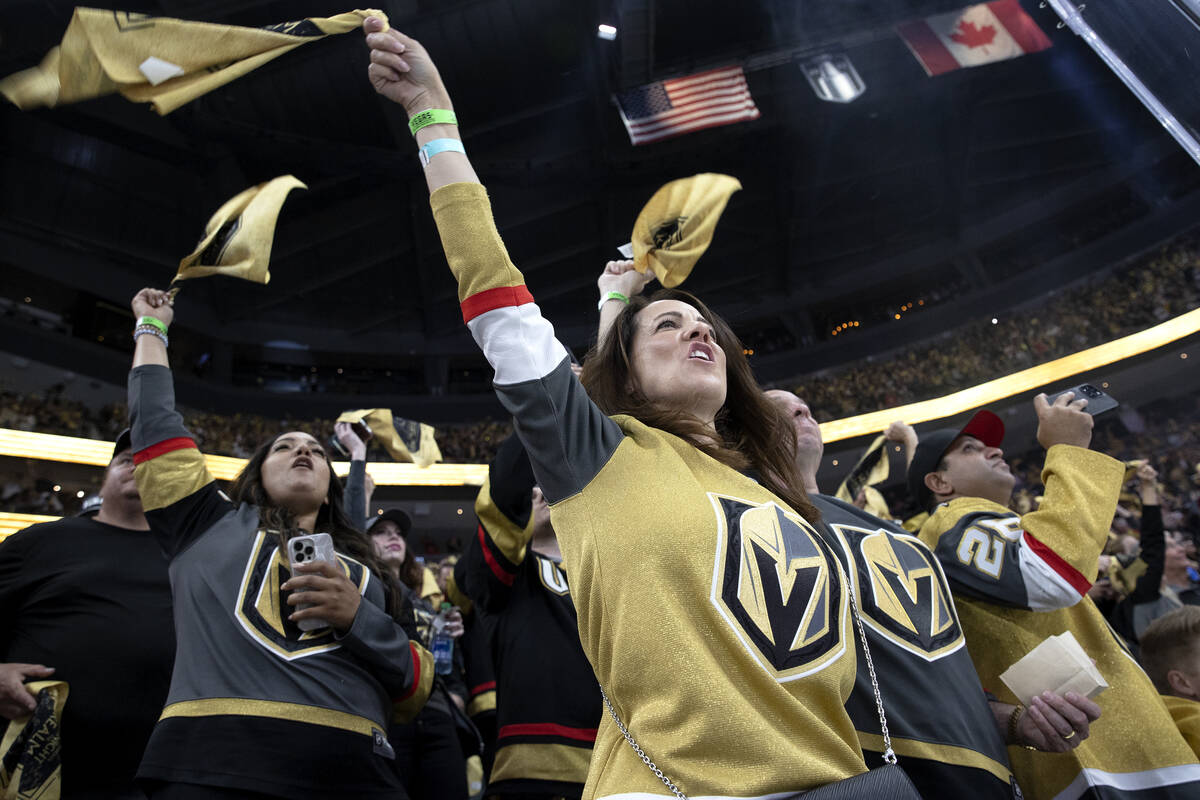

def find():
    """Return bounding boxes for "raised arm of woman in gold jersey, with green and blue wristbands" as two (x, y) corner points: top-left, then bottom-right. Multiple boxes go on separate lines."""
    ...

(364, 18), (623, 504)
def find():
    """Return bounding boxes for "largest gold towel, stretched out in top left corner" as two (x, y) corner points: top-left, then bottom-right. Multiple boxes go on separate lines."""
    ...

(0, 8), (388, 114)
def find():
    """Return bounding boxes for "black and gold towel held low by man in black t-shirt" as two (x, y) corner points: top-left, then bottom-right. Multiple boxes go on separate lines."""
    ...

(0, 680), (68, 800)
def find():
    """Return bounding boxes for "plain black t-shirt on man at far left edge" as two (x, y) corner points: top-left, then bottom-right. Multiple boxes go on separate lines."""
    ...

(0, 517), (175, 798)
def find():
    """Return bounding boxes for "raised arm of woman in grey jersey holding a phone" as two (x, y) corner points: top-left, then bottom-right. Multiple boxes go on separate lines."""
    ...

(128, 289), (233, 558)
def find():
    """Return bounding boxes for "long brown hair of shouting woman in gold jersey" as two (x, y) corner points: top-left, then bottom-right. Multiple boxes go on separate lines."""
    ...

(581, 289), (821, 524)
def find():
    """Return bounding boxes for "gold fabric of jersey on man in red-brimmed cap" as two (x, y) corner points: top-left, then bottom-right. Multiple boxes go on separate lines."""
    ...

(920, 445), (1200, 800)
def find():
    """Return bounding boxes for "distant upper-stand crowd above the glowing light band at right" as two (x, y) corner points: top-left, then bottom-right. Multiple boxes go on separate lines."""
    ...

(794, 237), (1200, 421)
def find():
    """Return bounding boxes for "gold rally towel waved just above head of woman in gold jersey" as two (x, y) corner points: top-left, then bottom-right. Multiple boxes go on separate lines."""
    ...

(632, 173), (742, 288)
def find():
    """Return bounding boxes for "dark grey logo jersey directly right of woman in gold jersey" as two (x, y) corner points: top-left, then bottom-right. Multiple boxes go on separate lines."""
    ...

(812, 494), (1014, 800)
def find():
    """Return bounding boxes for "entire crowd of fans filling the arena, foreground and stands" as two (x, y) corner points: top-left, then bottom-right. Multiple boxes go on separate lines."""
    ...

(0, 17), (1200, 800)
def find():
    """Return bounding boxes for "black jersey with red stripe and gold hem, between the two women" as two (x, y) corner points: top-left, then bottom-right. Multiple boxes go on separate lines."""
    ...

(455, 437), (601, 796)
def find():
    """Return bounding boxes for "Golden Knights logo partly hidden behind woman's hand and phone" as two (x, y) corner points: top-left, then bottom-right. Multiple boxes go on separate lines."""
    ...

(236, 530), (371, 661)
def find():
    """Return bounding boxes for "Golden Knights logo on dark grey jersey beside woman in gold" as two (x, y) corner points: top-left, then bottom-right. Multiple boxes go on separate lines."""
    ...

(828, 523), (965, 661)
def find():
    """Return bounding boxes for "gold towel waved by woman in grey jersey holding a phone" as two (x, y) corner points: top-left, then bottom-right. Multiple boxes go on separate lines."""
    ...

(172, 175), (308, 291)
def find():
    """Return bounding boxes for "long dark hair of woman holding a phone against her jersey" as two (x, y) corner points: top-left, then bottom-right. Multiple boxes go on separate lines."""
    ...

(229, 433), (406, 619)
